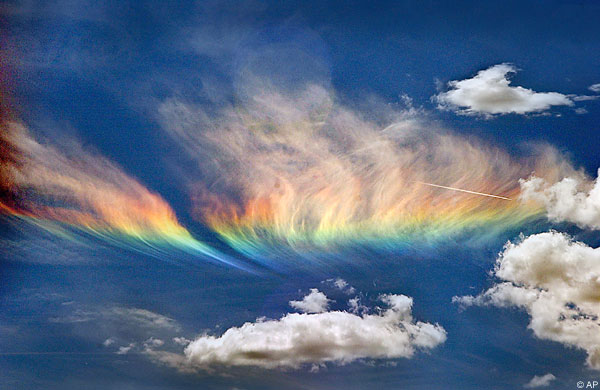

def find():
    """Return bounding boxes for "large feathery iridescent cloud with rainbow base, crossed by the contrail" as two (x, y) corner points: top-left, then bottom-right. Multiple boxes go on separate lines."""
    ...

(160, 85), (572, 256)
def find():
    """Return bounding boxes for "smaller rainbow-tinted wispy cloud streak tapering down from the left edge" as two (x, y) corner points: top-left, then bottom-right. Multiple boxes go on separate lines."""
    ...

(0, 121), (244, 270)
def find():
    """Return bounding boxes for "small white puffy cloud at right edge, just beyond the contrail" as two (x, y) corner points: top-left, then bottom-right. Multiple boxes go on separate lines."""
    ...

(519, 170), (600, 229)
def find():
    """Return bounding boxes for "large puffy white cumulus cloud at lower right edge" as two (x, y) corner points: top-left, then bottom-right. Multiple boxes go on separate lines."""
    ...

(453, 231), (600, 370)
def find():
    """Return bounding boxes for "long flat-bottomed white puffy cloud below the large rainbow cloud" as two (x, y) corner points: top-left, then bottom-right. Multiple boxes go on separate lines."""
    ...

(183, 295), (446, 370)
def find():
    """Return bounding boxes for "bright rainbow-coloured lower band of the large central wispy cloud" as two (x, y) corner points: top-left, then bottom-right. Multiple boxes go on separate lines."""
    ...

(199, 183), (545, 257)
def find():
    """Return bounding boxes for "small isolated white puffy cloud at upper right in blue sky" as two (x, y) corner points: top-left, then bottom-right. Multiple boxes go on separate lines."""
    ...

(433, 63), (573, 117)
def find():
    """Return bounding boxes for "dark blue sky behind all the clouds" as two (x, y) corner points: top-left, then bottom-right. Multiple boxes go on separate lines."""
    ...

(0, 1), (600, 390)
